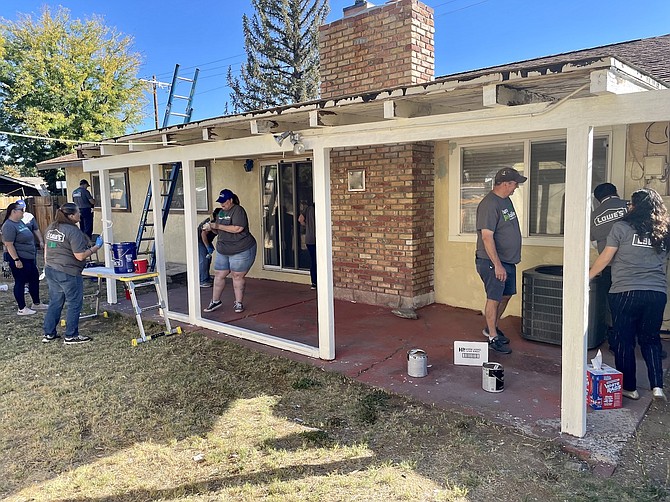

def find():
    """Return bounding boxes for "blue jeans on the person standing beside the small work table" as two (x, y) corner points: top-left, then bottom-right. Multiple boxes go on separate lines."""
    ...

(44, 267), (84, 338)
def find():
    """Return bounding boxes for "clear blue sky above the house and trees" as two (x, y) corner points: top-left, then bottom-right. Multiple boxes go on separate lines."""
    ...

(0, 0), (670, 130)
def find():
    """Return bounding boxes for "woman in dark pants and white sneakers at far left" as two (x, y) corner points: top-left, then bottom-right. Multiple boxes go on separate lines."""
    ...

(2, 202), (49, 315)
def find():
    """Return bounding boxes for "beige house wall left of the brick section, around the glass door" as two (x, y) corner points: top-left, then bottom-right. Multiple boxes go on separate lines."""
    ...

(66, 160), (309, 284)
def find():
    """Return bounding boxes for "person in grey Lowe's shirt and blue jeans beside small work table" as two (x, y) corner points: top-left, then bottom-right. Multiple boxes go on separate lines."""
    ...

(42, 202), (102, 345)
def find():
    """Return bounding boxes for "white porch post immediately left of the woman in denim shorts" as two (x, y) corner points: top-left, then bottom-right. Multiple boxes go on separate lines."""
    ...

(181, 159), (201, 323)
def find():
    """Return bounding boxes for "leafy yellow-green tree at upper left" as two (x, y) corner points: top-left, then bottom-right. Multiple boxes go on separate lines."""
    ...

(0, 8), (145, 175)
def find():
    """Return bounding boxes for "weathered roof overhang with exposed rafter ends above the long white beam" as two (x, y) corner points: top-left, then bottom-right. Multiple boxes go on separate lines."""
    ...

(79, 57), (667, 158)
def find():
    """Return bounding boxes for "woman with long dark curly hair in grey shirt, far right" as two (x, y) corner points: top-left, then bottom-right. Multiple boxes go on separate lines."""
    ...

(589, 188), (670, 401)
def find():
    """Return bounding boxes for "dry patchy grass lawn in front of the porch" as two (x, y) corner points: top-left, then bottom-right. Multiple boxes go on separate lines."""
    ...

(0, 279), (670, 502)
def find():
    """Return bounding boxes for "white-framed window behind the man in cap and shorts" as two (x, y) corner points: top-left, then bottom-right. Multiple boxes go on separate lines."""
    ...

(459, 136), (609, 237)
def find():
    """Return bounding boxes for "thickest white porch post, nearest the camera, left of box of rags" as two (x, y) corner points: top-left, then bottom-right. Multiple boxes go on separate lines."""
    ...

(561, 125), (593, 437)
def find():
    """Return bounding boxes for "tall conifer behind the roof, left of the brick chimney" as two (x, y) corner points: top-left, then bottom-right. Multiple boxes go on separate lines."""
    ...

(228, 0), (329, 112)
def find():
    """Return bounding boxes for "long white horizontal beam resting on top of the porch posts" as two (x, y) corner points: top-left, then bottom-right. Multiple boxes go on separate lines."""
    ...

(84, 89), (670, 172)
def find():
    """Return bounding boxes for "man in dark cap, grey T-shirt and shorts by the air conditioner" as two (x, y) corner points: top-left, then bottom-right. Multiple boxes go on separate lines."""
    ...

(475, 167), (528, 354)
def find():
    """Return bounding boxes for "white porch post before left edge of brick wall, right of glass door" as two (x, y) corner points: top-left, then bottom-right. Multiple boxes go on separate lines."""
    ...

(313, 144), (335, 360)
